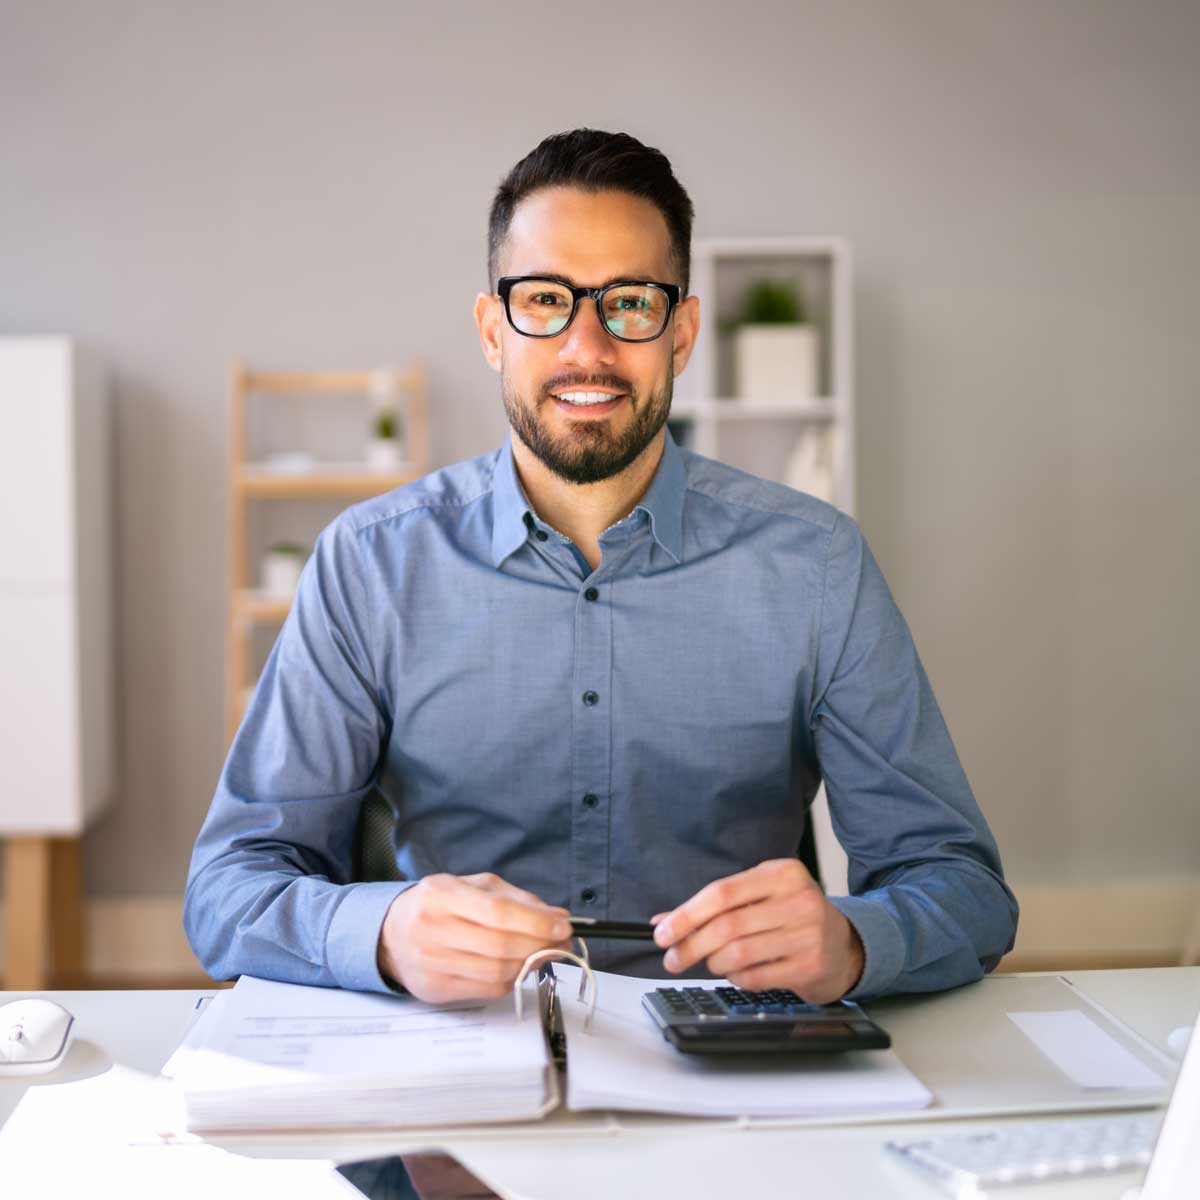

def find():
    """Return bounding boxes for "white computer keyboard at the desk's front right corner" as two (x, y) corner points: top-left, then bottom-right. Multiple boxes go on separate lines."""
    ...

(883, 1112), (1163, 1198)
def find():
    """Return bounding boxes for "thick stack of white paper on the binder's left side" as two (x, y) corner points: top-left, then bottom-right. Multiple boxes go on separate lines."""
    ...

(170, 976), (554, 1132)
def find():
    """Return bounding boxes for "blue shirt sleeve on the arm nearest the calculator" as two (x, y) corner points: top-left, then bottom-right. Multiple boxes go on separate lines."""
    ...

(809, 514), (1018, 1000)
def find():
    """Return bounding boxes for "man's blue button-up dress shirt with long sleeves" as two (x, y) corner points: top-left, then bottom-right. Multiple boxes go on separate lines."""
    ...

(184, 433), (1018, 997)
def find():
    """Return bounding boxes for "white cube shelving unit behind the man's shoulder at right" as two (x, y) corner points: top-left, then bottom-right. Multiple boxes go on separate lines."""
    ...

(671, 238), (854, 895)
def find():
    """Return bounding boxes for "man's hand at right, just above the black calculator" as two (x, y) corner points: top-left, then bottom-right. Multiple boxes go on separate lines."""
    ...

(650, 858), (863, 1004)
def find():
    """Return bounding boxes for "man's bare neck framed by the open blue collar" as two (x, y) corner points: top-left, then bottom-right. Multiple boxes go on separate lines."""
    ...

(512, 430), (666, 570)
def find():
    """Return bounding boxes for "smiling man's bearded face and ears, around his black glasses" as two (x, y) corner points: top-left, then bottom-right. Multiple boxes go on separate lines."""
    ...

(475, 187), (696, 484)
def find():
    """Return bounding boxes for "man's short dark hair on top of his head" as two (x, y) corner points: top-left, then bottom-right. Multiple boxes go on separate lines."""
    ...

(487, 128), (696, 295)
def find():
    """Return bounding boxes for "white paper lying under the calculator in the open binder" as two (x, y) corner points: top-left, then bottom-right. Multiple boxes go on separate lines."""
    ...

(554, 962), (934, 1117)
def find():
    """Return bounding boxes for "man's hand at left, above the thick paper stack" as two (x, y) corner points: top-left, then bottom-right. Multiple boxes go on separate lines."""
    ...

(377, 874), (571, 1003)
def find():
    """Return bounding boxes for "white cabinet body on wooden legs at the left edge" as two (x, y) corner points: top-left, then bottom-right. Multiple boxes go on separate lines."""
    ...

(0, 337), (114, 836)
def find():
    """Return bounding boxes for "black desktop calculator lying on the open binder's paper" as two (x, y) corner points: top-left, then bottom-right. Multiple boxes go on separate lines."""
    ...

(642, 986), (892, 1054)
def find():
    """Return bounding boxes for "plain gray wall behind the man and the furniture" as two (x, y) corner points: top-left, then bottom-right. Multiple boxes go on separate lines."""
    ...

(0, 0), (1200, 895)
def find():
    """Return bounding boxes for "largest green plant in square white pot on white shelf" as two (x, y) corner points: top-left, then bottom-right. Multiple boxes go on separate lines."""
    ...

(725, 280), (817, 400)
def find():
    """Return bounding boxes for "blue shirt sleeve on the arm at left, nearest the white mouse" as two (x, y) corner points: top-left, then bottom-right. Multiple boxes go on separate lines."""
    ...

(184, 518), (412, 992)
